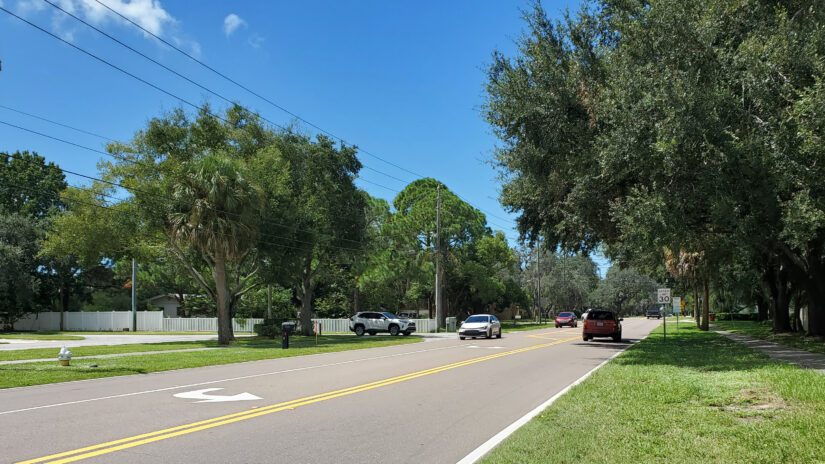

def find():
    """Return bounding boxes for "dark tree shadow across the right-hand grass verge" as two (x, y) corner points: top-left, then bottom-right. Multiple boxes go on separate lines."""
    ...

(614, 328), (775, 372)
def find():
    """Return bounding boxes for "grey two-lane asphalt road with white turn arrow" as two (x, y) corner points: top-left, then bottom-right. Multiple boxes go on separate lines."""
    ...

(0, 319), (659, 463)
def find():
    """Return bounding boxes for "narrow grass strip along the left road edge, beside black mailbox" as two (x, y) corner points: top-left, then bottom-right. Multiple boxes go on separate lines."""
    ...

(0, 335), (421, 388)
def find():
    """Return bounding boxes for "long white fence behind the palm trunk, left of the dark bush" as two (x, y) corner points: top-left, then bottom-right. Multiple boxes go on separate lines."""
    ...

(14, 311), (263, 332)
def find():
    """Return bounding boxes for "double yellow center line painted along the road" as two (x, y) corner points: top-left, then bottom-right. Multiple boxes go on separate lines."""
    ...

(18, 337), (578, 464)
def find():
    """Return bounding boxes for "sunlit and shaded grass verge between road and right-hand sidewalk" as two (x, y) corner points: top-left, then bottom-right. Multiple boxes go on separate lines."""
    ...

(483, 321), (825, 464)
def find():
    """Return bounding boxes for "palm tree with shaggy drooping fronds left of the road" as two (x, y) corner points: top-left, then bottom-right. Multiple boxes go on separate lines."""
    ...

(167, 155), (262, 345)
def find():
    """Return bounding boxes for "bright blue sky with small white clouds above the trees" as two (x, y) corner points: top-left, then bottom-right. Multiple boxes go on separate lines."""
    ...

(0, 0), (605, 273)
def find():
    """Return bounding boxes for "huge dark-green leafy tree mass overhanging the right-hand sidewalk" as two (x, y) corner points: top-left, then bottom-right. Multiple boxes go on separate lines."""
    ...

(487, 0), (825, 334)
